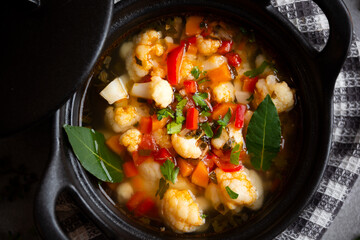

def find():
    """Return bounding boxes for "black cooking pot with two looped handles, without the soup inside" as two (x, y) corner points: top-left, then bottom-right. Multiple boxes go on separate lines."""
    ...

(35, 0), (352, 239)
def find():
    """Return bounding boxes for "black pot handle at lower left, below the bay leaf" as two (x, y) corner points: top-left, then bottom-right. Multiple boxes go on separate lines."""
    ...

(34, 110), (72, 240)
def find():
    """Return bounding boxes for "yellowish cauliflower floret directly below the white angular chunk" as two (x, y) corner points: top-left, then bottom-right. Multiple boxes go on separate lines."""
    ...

(105, 106), (140, 133)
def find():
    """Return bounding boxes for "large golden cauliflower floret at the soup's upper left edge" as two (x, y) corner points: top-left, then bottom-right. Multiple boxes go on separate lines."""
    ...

(124, 30), (165, 82)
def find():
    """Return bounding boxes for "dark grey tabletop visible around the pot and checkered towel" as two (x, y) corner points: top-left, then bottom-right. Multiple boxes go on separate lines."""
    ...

(0, 0), (360, 240)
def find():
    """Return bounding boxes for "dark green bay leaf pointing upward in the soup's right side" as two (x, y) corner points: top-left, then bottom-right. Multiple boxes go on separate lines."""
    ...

(246, 94), (281, 171)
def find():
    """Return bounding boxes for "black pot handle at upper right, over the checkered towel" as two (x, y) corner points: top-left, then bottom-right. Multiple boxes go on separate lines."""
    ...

(259, 0), (352, 96)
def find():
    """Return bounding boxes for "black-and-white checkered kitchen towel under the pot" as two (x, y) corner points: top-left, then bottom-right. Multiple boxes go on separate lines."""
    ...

(57, 0), (360, 240)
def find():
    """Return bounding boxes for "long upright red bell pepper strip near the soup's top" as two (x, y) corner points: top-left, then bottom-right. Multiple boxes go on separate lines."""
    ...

(167, 45), (185, 85)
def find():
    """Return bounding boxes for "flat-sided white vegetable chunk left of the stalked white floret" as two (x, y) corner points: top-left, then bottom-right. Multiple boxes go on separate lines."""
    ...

(100, 77), (129, 104)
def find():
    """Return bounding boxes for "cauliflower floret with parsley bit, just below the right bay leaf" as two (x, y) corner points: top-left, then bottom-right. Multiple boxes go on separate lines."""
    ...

(215, 168), (258, 211)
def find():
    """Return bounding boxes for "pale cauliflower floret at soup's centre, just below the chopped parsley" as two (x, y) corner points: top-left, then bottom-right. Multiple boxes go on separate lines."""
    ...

(171, 134), (201, 158)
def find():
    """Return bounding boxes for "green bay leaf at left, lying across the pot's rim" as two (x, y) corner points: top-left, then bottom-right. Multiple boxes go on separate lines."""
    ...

(63, 124), (124, 183)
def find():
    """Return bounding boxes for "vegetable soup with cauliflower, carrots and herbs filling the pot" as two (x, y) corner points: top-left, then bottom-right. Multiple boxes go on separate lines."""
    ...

(83, 16), (299, 233)
